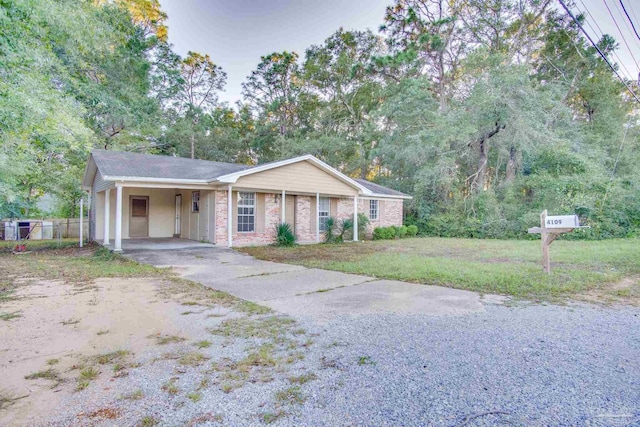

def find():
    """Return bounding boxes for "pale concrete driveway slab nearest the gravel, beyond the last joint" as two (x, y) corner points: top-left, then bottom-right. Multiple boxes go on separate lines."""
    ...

(256, 276), (484, 320)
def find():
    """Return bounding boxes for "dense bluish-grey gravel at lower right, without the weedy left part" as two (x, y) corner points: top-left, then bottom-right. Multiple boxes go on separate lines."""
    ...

(281, 305), (640, 426)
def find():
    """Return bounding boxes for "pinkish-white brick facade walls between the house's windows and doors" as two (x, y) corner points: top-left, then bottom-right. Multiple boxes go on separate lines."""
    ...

(215, 191), (402, 246)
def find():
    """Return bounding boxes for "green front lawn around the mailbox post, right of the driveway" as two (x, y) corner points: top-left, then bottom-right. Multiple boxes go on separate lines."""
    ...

(239, 238), (640, 301)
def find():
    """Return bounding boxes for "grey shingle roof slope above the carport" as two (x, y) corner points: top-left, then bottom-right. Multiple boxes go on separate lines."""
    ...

(92, 150), (251, 181)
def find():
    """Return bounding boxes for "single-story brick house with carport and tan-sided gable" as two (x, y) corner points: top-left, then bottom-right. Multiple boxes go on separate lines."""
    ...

(82, 150), (411, 251)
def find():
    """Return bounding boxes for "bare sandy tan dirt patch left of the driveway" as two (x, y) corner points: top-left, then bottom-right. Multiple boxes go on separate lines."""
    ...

(0, 278), (180, 425)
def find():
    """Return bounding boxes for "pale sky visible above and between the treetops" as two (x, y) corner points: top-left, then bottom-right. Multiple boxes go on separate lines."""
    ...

(160, 0), (640, 105)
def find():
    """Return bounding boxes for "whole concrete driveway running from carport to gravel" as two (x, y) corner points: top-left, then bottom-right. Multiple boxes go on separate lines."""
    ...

(125, 247), (499, 320)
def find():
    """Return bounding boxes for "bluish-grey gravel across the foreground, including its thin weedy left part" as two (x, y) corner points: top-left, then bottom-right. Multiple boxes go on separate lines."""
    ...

(38, 290), (640, 427)
